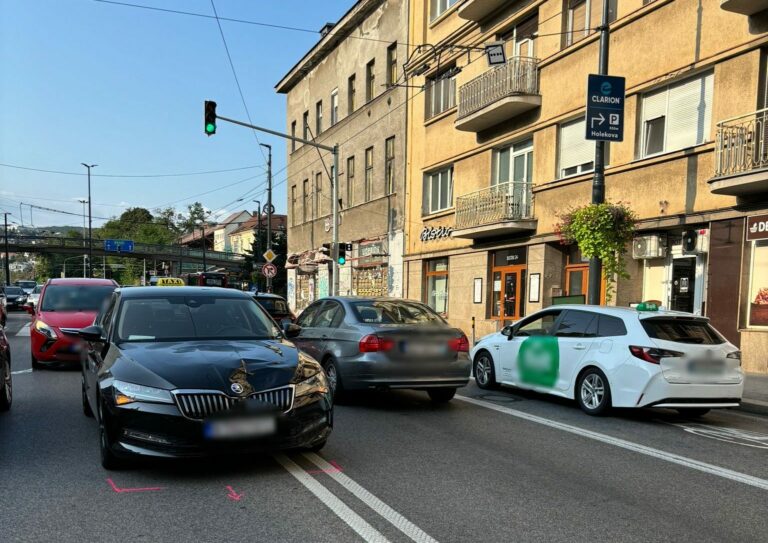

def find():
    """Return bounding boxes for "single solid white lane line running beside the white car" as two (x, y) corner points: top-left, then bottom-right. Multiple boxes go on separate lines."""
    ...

(456, 394), (768, 490)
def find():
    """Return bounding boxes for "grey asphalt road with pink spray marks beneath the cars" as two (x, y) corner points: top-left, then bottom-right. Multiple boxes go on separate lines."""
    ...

(0, 314), (768, 543)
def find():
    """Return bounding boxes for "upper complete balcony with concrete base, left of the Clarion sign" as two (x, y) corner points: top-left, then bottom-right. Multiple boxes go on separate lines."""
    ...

(455, 57), (541, 132)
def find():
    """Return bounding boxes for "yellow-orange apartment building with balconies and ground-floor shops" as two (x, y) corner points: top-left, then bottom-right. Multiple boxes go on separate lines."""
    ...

(404, 0), (768, 372)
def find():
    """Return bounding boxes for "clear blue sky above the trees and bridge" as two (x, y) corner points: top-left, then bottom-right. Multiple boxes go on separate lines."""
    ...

(0, 0), (353, 230)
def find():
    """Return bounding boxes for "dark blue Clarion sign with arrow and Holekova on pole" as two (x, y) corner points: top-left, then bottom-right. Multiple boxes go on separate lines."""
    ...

(586, 74), (625, 141)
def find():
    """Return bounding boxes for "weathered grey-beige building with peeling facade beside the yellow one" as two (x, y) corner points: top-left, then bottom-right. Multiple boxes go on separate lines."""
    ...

(276, 0), (408, 310)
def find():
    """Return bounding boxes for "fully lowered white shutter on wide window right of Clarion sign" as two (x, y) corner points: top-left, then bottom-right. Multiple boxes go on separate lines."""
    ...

(666, 72), (713, 151)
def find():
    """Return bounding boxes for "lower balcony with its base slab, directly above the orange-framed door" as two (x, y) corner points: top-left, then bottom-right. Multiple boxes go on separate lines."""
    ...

(453, 182), (536, 239)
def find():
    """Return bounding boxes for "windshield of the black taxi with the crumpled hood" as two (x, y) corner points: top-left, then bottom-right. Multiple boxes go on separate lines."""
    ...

(116, 296), (280, 342)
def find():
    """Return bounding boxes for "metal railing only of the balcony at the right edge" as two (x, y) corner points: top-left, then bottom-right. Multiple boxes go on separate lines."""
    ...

(715, 108), (768, 177)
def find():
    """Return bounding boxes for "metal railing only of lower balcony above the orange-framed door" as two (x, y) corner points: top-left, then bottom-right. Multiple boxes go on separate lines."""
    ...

(454, 181), (533, 230)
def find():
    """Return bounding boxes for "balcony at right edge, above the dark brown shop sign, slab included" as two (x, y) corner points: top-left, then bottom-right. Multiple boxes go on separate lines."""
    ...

(709, 108), (768, 196)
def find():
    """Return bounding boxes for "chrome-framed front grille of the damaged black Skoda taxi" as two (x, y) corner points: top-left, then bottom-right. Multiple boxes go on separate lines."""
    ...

(173, 386), (293, 420)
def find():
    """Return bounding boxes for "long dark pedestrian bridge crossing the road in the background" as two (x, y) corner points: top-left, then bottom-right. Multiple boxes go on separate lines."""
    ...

(0, 234), (244, 270)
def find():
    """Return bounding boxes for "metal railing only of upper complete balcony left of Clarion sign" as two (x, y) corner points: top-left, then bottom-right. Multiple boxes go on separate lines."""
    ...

(458, 57), (539, 119)
